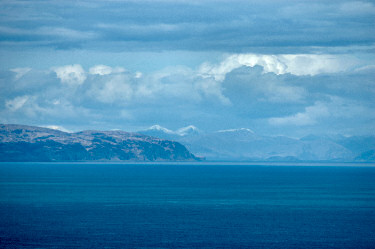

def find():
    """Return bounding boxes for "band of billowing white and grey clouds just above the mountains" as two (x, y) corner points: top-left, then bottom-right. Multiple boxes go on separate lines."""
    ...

(0, 54), (375, 136)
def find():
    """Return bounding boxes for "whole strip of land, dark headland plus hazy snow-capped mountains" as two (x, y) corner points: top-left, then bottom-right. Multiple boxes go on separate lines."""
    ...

(0, 124), (375, 162)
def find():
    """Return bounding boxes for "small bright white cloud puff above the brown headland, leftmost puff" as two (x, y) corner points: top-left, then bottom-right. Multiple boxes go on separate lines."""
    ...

(52, 64), (86, 86)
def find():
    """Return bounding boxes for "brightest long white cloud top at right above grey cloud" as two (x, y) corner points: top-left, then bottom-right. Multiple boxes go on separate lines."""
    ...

(199, 54), (354, 81)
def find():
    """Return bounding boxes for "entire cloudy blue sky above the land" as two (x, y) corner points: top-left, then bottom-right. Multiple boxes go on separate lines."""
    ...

(0, 0), (375, 137)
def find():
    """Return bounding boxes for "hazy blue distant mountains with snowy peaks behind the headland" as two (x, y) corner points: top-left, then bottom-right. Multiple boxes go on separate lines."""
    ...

(139, 126), (375, 162)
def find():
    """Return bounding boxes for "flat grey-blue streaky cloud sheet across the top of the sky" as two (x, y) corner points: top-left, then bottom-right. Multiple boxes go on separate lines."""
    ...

(0, 0), (374, 53)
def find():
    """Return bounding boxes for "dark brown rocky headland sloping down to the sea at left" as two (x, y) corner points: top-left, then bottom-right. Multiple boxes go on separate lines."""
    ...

(0, 125), (199, 162)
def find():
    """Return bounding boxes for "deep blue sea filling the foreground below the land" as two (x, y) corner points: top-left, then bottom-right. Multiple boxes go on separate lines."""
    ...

(0, 163), (375, 248)
